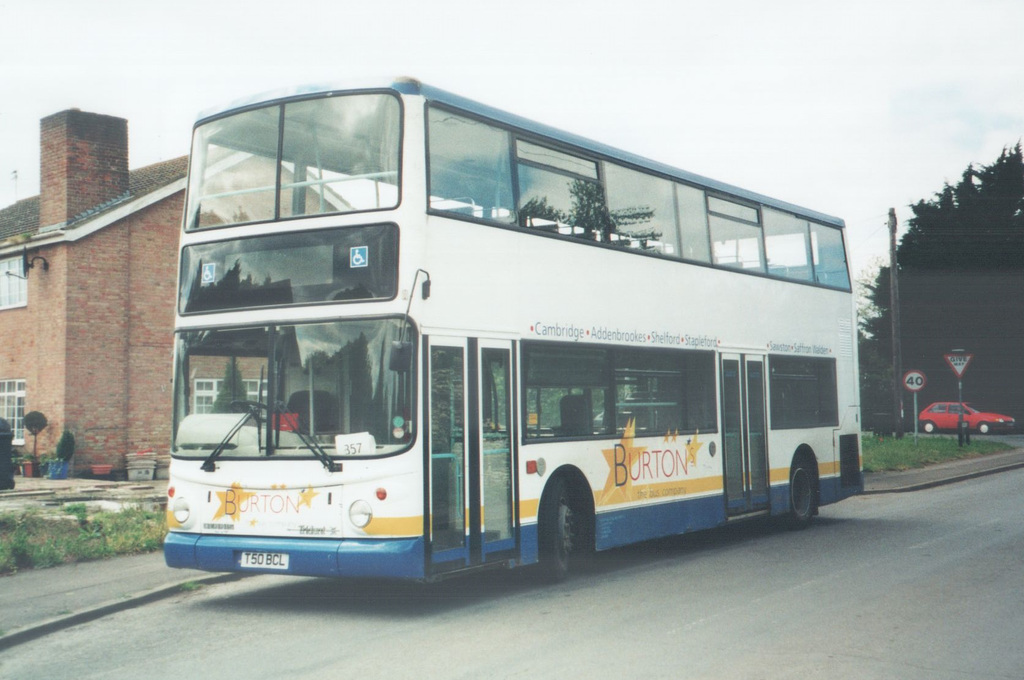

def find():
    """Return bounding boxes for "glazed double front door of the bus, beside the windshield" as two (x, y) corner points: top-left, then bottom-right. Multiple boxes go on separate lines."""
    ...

(428, 338), (515, 573)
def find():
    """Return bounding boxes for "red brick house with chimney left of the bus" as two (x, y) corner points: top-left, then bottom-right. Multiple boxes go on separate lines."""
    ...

(0, 110), (187, 472)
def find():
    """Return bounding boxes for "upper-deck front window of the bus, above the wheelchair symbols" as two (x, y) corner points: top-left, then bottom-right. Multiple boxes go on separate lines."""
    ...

(185, 93), (401, 229)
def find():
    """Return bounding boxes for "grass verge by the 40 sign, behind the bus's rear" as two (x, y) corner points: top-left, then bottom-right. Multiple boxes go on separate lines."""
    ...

(860, 432), (1013, 472)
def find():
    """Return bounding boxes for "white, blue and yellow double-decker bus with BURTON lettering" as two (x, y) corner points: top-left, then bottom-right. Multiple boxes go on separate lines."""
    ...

(165, 79), (863, 581)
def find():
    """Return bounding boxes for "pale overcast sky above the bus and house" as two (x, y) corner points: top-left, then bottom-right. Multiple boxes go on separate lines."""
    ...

(0, 0), (1024, 273)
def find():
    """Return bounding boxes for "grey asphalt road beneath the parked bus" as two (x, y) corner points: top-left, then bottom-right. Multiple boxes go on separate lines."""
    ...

(0, 470), (1024, 680)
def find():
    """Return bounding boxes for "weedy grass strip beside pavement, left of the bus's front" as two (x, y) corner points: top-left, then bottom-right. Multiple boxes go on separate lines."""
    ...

(0, 503), (167, 575)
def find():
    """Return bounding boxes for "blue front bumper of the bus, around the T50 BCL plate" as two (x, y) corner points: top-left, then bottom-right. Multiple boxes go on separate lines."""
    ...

(164, 532), (424, 579)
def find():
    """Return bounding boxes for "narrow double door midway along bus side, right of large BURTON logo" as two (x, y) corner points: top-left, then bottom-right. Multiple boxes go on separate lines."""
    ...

(721, 354), (768, 515)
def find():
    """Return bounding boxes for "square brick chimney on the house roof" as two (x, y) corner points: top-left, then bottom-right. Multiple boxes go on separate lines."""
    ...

(39, 109), (128, 227)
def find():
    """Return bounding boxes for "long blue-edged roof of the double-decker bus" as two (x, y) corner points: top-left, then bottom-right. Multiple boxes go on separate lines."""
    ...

(197, 77), (845, 228)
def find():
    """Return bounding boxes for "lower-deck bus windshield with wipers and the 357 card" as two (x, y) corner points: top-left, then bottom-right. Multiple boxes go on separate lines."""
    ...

(173, 320), (415, 458)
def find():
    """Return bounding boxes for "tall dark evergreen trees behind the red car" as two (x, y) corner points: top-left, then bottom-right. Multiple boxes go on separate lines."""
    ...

(859, 143), (1024, 422)
